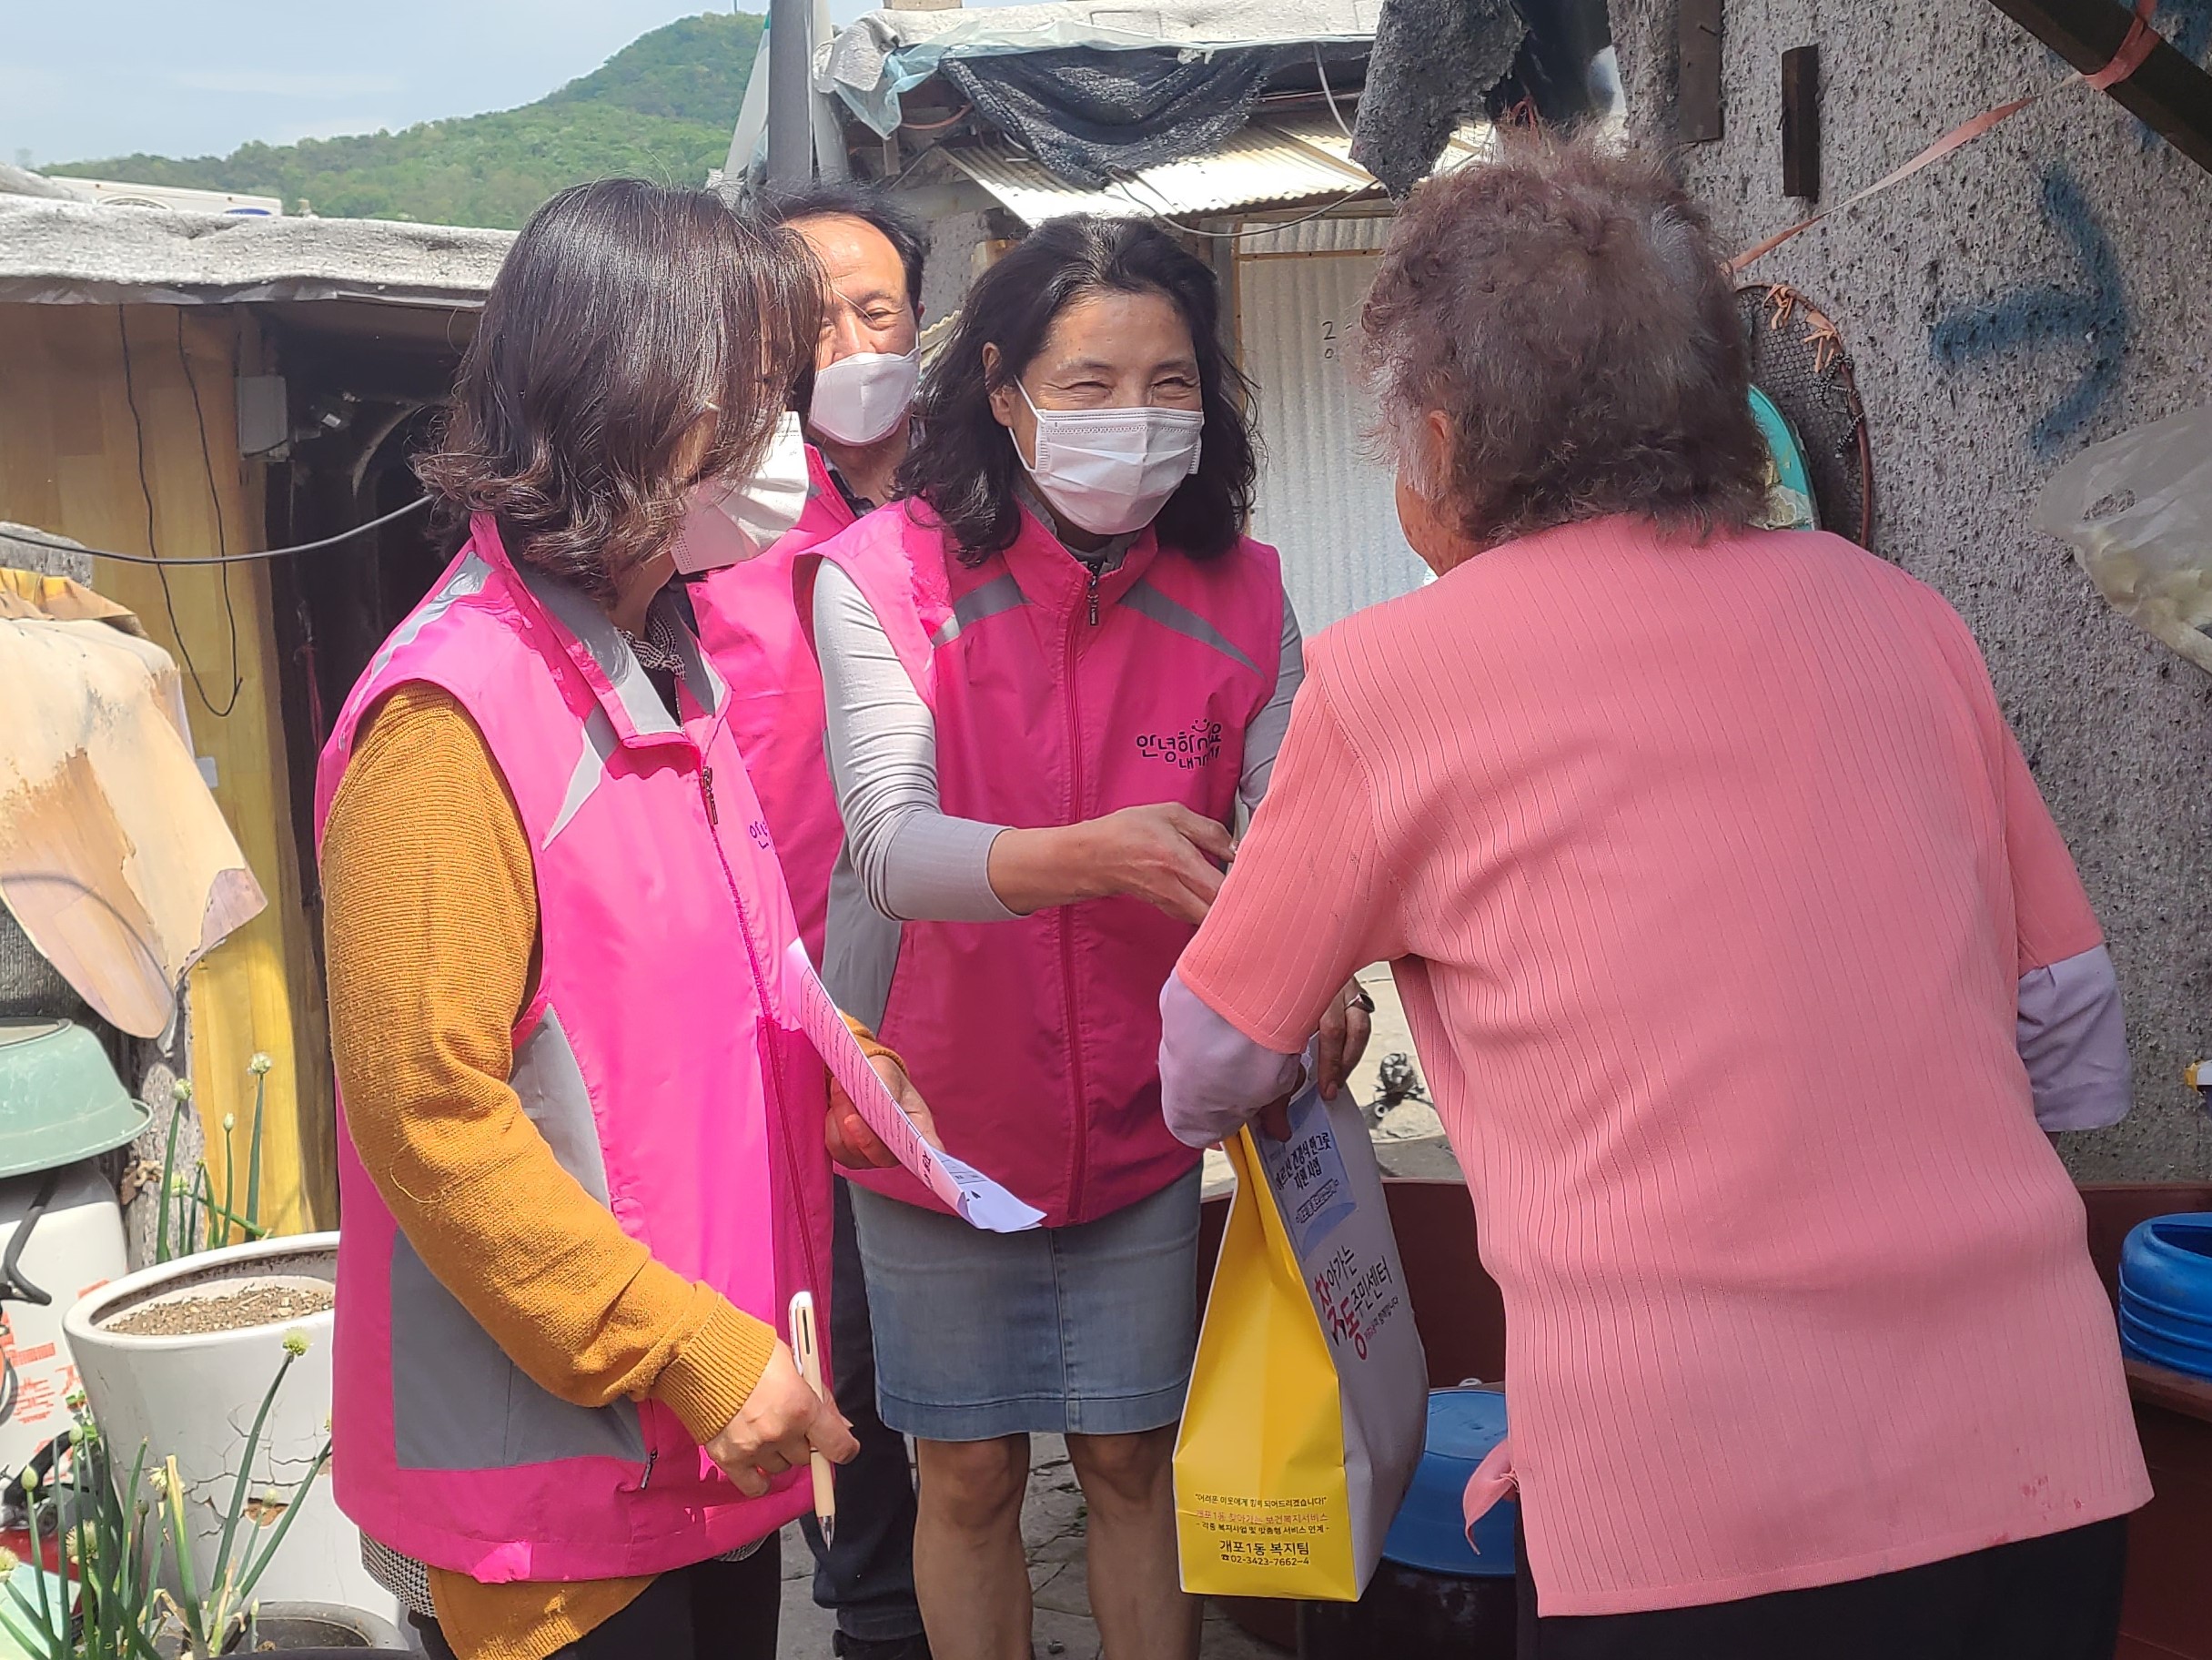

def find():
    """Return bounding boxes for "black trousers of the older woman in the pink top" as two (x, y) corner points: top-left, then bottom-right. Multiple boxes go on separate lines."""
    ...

(1515, 1521), (2128, 1660)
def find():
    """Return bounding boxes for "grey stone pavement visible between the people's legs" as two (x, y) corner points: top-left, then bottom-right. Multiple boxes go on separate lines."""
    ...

(776, 1434), (1283, 1660)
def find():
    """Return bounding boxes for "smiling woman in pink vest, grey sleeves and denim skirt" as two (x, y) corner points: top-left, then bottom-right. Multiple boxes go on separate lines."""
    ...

(814, 219), (1343, 1660)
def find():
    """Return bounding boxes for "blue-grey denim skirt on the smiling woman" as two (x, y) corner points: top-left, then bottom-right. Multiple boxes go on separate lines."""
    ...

(852, 1171), (1199, 1441)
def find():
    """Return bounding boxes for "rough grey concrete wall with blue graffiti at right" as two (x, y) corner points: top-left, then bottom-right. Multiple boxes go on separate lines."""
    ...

(1611, 0), (2212, 1179)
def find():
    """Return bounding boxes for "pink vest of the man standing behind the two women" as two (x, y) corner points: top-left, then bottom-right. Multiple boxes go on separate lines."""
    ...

(690, 445), (853, 963)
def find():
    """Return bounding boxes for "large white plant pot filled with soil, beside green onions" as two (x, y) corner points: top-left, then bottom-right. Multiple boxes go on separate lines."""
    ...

(64, 1233), (400, 1620)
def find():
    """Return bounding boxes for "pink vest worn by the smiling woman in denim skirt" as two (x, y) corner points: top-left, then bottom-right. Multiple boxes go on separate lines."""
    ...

(814, 502), (1283, 1226)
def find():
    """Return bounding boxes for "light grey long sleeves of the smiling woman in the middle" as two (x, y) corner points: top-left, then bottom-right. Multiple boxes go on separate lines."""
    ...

(814, 555), (1305, 923)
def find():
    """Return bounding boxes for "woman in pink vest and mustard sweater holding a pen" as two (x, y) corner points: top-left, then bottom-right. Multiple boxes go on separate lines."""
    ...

(317, 179), (915, 1660)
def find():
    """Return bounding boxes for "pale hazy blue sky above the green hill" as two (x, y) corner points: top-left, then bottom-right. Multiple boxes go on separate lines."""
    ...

(0, 0), (968, 166)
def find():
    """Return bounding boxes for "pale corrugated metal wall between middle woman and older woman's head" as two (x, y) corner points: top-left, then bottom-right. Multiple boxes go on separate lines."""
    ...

(1237, 219), (1429, 633)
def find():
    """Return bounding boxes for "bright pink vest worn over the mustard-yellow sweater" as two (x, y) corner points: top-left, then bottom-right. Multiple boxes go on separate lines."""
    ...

(317, 516), (830, 1583)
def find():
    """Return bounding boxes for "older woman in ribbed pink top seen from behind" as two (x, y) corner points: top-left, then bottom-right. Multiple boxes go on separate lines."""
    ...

(1161, 147), (2150, 1660)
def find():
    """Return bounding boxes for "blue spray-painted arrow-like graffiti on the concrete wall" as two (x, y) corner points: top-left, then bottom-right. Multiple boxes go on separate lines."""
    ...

(1929, 164), (2132, 458)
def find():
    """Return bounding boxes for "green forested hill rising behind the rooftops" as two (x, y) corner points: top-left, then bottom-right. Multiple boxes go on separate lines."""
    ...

(45, 14), (763, 228)
